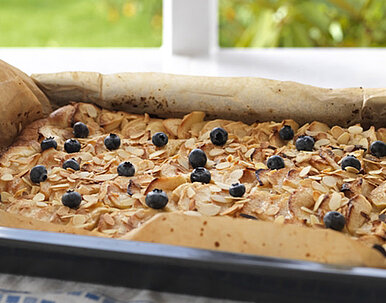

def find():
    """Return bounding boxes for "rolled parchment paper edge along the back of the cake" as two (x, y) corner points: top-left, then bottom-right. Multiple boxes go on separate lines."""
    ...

(32, 72), (386, 127)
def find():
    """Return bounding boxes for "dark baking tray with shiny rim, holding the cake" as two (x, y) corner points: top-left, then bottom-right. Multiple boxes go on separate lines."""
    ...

(0, 227), (386, 302)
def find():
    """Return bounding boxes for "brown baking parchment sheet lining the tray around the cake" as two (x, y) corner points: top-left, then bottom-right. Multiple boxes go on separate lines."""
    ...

(0, 61), (386, 267)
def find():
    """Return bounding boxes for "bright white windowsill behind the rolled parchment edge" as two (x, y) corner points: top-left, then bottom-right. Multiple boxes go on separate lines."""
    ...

(0, 48), (386, 87)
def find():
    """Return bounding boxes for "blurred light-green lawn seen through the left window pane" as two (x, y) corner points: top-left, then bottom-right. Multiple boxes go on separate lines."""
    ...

(0, 0), (162, 47)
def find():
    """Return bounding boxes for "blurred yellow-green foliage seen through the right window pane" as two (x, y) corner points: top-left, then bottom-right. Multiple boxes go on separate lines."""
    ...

(219, 0), (386, 47)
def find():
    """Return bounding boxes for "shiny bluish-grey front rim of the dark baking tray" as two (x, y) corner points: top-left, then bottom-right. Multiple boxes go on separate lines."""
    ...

(0, 227), (386, 280)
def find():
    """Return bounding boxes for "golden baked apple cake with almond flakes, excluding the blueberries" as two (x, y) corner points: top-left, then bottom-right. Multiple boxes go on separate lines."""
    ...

(0, 103), (386, 264)
